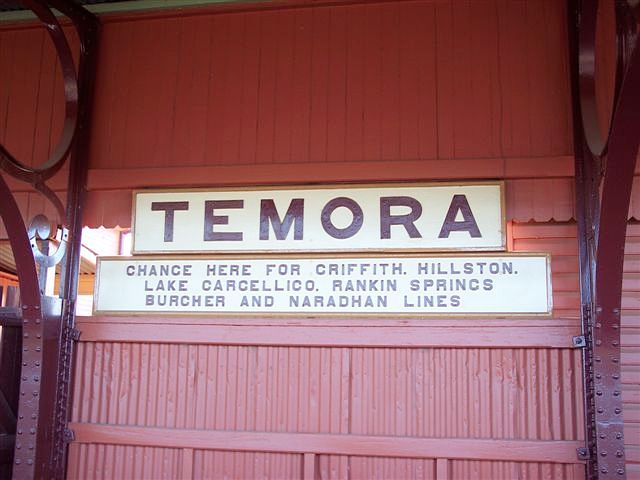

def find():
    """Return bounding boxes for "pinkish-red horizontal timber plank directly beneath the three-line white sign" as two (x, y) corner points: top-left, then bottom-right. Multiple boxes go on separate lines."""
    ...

(78, 319), (580, 348)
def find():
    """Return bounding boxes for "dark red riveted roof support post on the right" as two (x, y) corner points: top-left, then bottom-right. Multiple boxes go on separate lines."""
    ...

(568, 0), (640, 479)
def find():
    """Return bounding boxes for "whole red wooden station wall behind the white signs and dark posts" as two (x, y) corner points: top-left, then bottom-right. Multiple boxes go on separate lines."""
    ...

(0, 0), (640, 479)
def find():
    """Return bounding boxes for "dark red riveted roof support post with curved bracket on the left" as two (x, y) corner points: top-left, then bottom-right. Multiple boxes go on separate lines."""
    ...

(0, 0), (99, 479)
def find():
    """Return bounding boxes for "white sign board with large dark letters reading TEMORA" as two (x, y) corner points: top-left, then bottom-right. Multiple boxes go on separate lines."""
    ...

(132, 182), (505, 254)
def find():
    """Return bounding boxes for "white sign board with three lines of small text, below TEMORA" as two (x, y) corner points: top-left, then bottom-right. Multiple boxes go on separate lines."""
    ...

(94, 254), (551, 315)
